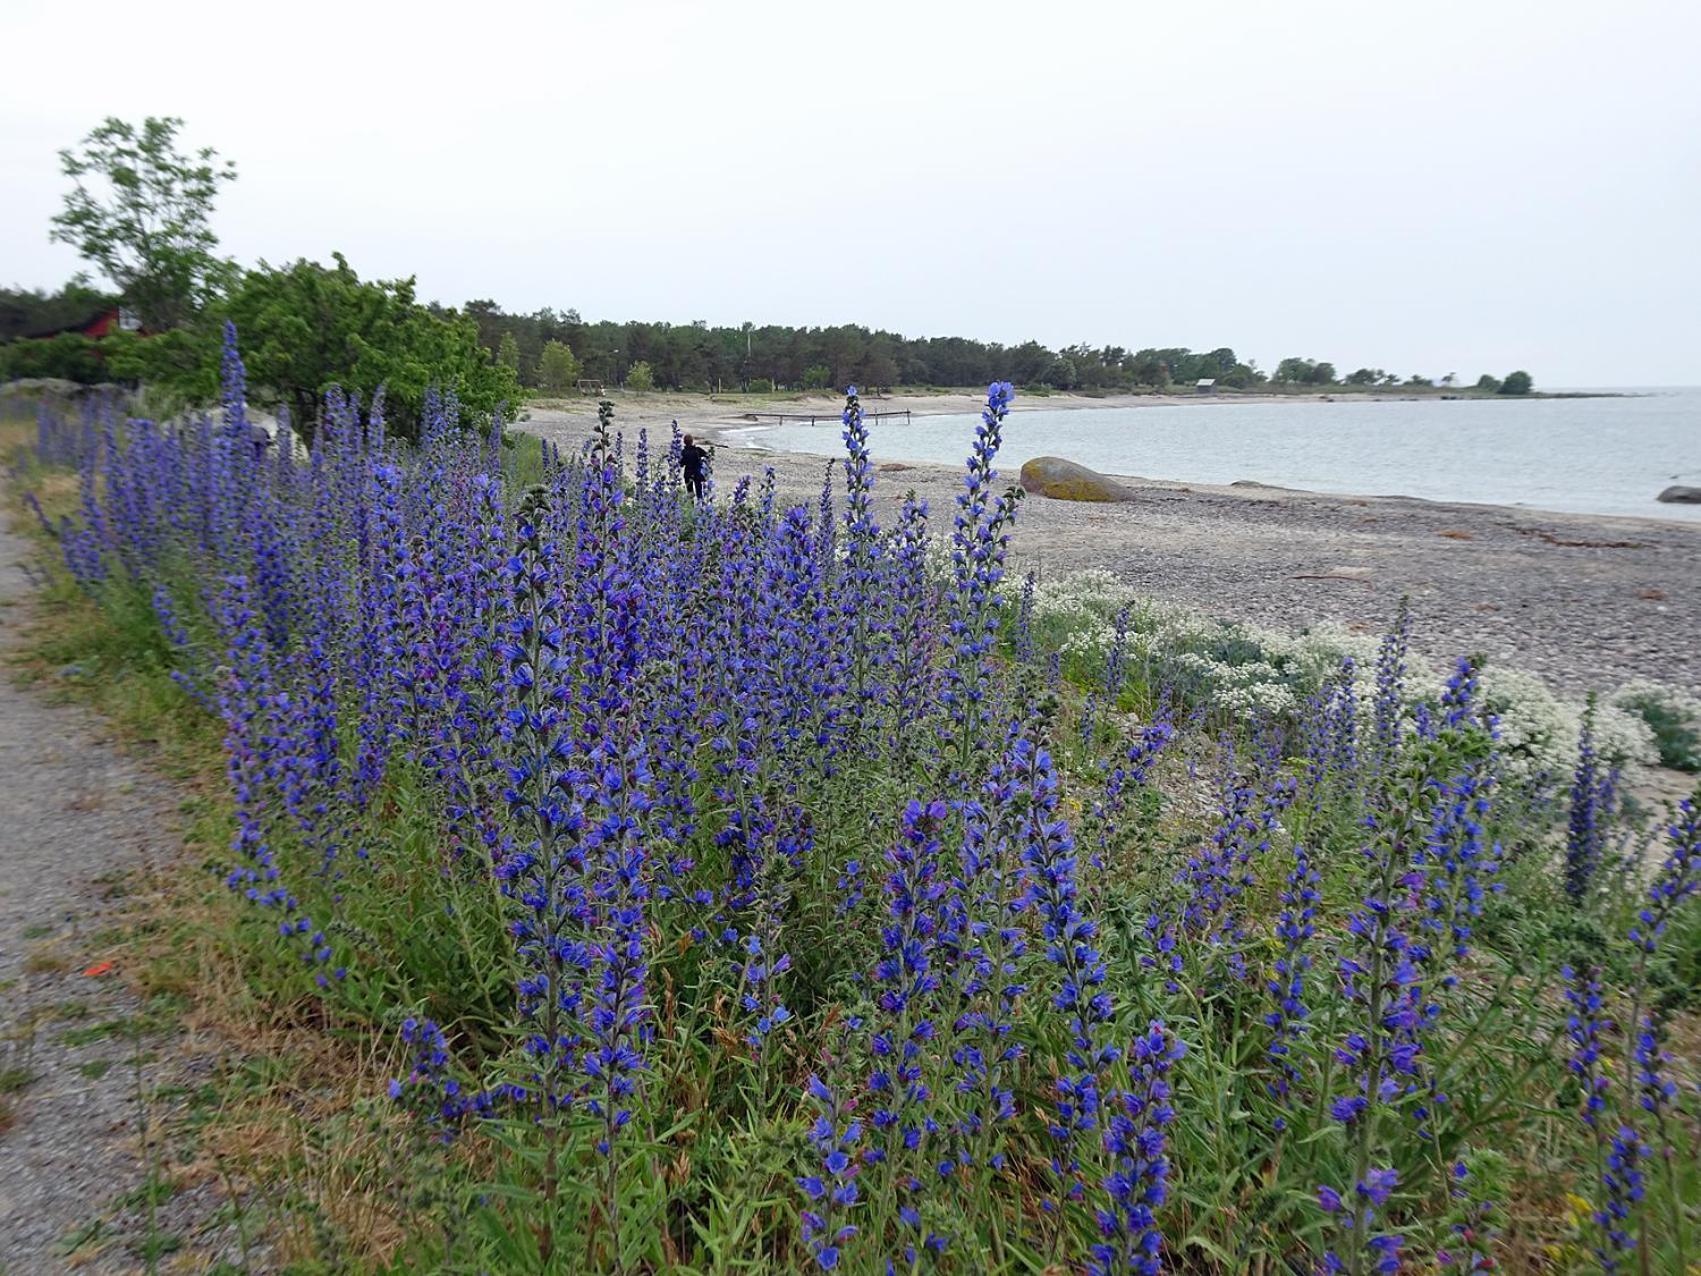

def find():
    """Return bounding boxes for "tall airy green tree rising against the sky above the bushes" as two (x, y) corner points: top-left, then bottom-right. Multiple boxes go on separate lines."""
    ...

(51, 116), (236, 328)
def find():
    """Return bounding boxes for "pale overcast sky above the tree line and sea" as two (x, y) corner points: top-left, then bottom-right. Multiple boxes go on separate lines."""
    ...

(0, 0), (1701, 386)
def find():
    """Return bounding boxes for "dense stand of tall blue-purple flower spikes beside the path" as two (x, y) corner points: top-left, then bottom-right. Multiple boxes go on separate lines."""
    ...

(59, 347), (1653, 1273)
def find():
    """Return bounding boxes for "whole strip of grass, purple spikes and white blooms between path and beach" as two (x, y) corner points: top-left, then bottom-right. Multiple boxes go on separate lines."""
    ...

(6, 332), (1701, 1273)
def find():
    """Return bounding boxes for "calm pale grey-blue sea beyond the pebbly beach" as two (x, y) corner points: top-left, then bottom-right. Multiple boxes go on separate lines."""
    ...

(750, 388), (1701, 521)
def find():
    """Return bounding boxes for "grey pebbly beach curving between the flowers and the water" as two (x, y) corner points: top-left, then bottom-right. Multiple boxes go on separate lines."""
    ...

(521, 393), (1701, 692)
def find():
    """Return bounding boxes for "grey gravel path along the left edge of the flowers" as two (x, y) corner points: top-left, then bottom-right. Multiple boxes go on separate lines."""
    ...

(0, 517), (210, 1276)
